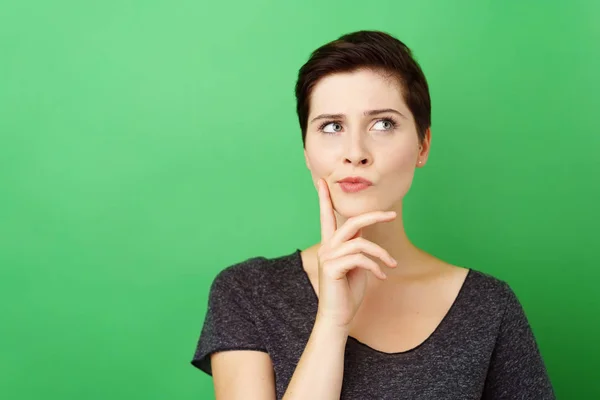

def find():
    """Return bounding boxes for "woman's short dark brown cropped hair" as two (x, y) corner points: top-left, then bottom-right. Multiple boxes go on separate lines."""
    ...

(295, 30), (431, 145)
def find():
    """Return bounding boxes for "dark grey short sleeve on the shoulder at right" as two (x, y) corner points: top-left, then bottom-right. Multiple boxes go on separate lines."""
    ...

(483, 282), (556, 400)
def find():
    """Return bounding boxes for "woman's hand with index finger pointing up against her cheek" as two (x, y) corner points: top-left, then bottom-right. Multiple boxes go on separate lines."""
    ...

(317, 179), (397, 329)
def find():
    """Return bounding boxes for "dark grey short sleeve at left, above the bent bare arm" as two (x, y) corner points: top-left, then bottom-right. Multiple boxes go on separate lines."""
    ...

(191, 265), (267, 376)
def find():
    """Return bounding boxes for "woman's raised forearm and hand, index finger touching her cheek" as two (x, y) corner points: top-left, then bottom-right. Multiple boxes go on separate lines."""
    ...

(283, 179), (397, 400)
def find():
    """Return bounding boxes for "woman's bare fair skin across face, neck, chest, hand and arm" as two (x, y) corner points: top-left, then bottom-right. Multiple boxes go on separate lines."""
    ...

(211, 70), (467, 400)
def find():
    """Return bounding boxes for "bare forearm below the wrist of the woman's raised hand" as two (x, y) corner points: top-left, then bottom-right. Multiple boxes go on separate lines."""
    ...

(283, 318), (348, 400)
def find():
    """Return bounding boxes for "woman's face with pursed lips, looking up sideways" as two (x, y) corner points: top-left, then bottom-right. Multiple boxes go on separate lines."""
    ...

(304, 70), (431, 218)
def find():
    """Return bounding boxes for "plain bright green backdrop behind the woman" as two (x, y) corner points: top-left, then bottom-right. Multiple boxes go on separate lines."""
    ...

(0, 0), (600, 400)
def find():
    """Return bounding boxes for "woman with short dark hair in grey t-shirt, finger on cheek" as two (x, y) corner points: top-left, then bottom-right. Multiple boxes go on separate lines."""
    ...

(192, 31), (555, 400)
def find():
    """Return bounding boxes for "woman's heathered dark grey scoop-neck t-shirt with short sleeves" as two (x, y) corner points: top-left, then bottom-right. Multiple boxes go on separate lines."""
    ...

(192, 249), (555, 400)
